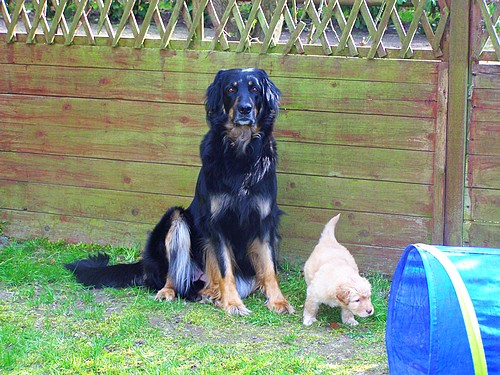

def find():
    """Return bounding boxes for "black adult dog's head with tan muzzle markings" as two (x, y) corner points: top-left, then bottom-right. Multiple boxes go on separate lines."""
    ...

(205, 69), (280, 147)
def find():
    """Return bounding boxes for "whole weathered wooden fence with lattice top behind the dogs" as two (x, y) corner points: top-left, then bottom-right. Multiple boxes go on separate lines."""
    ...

(0, 0), (500, 272)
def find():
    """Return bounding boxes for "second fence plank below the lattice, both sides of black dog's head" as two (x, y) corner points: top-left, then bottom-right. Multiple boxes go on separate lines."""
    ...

(0, 64), (436, 117)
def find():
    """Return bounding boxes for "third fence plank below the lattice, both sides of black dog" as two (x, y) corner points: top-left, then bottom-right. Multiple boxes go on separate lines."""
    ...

(0, 94), (436, 151)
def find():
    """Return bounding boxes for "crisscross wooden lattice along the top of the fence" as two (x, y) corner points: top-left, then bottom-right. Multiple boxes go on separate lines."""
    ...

(0, 0), (500, 59)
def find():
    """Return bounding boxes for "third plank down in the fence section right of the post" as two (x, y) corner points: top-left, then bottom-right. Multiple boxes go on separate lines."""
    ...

(468, 119), (500, 157)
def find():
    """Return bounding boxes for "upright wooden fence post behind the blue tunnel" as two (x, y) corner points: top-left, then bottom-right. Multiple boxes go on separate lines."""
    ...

(444, 0), (471, 246)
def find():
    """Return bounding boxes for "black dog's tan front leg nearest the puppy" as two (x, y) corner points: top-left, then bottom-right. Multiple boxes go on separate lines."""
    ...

(249, 240), (295, 314)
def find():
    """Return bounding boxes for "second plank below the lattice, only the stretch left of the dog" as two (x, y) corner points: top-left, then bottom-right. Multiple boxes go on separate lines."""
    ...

(0, 64), (213, 104)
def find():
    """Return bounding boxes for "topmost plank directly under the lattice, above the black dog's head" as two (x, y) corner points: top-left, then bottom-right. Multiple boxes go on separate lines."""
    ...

(0, 43), (440, 84)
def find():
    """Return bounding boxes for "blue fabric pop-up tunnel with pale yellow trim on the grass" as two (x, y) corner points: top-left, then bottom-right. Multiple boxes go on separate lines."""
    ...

(386, 244), (500, 375)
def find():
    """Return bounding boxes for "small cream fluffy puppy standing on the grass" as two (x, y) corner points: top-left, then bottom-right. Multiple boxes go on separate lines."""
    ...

(303, 214), (373, 326)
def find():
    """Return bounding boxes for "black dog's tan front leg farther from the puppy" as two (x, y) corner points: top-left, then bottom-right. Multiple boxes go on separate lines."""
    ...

(200, 242), (251, 315)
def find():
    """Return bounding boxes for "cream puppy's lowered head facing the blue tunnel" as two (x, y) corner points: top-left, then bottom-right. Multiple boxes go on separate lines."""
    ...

(336, 276), (373, 318)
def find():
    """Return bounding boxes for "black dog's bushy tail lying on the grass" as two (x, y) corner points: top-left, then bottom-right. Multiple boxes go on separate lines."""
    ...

(64, 253), (143, 288)
